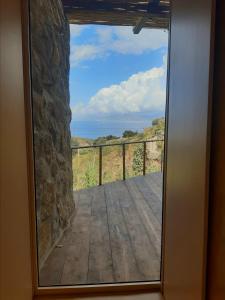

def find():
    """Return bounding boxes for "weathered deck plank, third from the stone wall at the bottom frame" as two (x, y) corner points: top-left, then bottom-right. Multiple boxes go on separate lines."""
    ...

(88, 186), (114, 284)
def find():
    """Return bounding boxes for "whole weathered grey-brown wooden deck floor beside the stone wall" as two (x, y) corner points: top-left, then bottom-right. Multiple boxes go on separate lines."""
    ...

(39, 173), (162, 286)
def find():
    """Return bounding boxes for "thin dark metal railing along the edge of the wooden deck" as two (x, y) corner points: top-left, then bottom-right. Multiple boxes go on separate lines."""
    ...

(71, 139), (164, 185)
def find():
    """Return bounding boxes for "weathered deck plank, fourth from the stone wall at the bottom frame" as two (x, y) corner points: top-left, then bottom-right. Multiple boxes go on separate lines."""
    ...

(105, 183), (142, 282)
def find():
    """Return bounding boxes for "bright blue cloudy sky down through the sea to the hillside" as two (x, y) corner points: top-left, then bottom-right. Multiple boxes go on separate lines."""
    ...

(70, 25), (168, 138)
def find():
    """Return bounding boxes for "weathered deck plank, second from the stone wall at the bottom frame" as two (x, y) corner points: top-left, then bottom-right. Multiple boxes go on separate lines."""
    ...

(61, 190), (92, 285)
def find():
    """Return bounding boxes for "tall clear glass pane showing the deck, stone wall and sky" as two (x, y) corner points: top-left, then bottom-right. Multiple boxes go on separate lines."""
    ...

(30, 0), (170, 287)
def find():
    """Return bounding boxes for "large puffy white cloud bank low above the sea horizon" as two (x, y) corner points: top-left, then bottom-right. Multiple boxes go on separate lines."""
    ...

(72, 57), (166, 120)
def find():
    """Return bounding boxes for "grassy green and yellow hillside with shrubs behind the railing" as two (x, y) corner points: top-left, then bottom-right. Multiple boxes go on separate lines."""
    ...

(71, 118), (165, 190)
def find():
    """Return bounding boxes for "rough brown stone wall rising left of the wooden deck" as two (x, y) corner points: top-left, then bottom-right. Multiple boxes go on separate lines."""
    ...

(30, 0), (74, 265)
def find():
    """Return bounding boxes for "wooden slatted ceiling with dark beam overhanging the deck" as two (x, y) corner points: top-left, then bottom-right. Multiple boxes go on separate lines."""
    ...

(62, 0), (171, 33)
